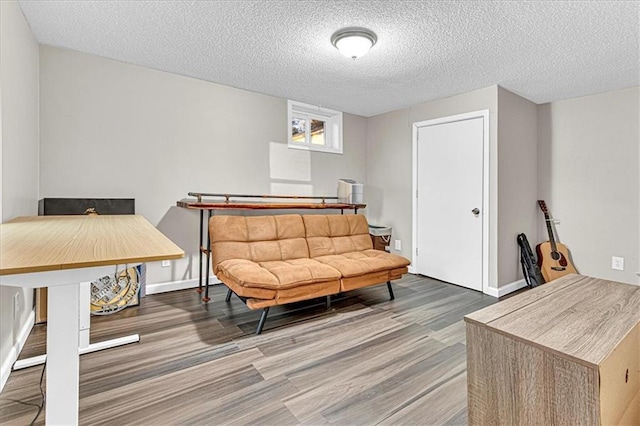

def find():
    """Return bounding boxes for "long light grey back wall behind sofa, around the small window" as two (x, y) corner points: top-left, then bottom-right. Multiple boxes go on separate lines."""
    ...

(40, 46), (366, 283)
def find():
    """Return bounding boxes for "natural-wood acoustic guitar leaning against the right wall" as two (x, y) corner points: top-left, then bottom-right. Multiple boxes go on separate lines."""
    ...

(536, 200), (578, 282)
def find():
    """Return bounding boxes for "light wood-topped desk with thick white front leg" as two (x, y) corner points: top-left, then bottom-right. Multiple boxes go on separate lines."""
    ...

(0, 215), (184, 425)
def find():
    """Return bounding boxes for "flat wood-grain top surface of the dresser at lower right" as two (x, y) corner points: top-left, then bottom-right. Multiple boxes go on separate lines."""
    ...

(465, 274), (640, 366)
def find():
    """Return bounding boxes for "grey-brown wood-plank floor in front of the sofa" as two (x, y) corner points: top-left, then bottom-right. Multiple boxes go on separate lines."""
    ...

(0, 275), (496, 425)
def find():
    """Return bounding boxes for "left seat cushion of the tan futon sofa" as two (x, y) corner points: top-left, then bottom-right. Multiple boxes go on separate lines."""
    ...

(218, 259), (340, 290)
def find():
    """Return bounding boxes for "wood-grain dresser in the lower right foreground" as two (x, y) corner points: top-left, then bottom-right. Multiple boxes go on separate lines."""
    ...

(465, 274), (640, 425)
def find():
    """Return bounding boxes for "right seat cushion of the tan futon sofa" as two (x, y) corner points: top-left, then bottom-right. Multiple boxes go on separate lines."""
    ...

(313, 249), (410, 277)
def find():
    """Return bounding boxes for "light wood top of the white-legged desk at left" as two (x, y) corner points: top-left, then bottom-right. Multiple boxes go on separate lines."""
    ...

(0, 215), (184, 275)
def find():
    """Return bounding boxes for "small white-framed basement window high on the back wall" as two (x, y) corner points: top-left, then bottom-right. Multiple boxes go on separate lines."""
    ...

(287, 101), (342, 154)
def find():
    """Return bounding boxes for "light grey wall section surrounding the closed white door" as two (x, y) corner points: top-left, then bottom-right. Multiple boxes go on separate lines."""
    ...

(365, 86), (498, 287)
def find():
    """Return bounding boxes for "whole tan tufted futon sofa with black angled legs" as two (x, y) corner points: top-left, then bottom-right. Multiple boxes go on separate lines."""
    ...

(209, 214), (410, 334)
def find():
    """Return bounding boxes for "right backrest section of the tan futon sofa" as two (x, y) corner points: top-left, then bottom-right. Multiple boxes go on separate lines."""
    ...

(302, 214), (373, 258)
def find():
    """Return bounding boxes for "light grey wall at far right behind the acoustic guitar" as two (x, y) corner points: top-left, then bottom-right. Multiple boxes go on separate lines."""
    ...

(538, 87), (640, 283)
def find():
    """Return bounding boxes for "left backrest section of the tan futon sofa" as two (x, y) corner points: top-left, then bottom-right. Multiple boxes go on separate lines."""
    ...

(209, 214), (309, 273)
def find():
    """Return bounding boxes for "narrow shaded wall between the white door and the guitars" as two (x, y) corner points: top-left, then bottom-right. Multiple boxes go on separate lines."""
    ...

(497, 87), (539, 286)
